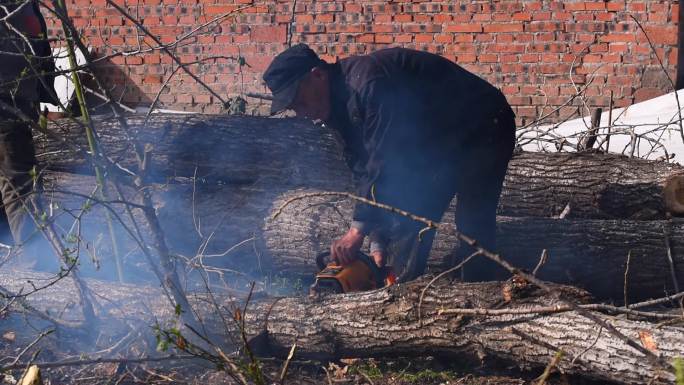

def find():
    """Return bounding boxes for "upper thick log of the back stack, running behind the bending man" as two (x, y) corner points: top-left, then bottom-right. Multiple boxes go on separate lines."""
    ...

(35, 114), (684, 219)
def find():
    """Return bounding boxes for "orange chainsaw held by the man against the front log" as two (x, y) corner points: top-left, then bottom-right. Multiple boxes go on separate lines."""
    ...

(309, 252), (396, 295)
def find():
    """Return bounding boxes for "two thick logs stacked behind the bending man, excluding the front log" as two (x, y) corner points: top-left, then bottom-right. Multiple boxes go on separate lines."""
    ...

(37, 115), (684, 300)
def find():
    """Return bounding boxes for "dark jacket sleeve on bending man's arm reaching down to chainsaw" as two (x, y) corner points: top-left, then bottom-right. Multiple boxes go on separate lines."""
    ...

(352, 79), (415, 234)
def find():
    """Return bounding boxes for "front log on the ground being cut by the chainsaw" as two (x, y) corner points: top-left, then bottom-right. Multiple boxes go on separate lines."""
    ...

(0, 270), (684, 384)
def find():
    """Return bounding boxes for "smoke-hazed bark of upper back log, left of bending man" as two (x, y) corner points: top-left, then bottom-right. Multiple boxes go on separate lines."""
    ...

(34, 114), (349, 189)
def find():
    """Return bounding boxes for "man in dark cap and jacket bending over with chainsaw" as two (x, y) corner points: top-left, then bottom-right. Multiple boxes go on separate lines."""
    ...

(263, 44), (515, 280)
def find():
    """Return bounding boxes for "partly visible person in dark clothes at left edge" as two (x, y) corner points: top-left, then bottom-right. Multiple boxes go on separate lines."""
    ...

(0, 0), (54, 258)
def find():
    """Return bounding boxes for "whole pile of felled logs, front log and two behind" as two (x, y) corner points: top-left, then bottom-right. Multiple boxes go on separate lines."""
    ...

(10, 116), (684, 384)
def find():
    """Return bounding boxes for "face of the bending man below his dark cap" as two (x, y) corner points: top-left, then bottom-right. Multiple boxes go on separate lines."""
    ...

(290, 67), (331, 121)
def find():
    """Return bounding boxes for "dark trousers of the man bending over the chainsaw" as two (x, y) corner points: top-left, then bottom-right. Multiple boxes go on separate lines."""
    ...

(391, 105), (515, 282)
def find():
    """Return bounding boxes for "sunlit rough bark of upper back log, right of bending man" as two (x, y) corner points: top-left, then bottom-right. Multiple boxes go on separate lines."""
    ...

(499, 153), (684, 220)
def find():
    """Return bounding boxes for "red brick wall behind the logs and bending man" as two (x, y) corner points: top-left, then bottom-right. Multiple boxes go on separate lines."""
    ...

(44, 0), (678, 122)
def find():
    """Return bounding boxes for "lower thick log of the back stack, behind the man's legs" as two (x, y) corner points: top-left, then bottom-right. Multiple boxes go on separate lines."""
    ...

(40, 173), (684, 302)
